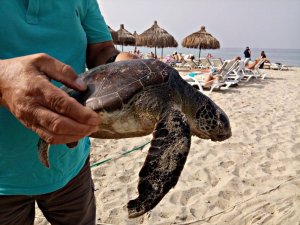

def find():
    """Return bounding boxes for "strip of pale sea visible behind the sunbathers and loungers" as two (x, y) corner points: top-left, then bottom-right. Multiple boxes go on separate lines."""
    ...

(116, 45), (300, 67)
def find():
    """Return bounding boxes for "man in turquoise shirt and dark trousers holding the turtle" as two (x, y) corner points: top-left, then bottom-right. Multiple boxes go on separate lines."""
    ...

(0, 0), (134, 225)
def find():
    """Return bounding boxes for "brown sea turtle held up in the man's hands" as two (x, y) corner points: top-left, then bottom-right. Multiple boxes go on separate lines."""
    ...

(39, 59), (231, 218)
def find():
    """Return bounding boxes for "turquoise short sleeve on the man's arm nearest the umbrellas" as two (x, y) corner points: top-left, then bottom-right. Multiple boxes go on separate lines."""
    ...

(82, 0), (112, 44)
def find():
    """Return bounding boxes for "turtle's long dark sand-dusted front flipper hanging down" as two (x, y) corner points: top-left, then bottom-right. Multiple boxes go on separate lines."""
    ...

(127, 109), (191, 218)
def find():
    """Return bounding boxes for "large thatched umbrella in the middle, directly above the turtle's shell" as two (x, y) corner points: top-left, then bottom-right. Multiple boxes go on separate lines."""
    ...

(136, 21), (178, 55)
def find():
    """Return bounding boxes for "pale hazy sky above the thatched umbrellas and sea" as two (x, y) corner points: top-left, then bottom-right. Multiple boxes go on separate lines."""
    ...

(98, 0), (300, 49)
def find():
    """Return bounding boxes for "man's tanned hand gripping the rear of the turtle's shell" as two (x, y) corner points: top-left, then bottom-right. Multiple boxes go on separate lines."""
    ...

(0, 54), (100, 144)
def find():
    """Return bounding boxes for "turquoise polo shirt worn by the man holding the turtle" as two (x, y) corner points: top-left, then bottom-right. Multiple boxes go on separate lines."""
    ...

(0, 0), (111, 195)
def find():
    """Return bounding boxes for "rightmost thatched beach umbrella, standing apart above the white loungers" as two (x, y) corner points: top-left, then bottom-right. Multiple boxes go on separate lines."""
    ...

(181, 26), (220, 58)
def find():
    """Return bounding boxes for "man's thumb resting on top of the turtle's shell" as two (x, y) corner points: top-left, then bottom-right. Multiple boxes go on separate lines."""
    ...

(32, 53), (86, 91)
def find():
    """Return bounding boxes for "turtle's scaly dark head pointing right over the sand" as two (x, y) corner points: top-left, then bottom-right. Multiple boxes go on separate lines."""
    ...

(191, 99), (231, 141)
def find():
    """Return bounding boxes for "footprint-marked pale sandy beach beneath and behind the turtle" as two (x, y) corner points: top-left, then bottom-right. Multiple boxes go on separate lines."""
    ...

(35, 68), (300, 225)
